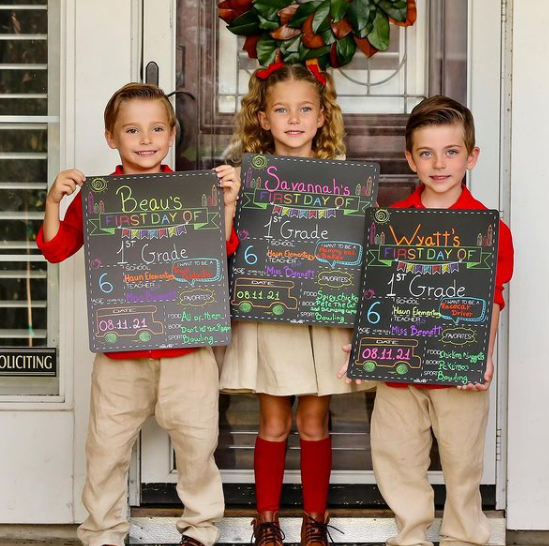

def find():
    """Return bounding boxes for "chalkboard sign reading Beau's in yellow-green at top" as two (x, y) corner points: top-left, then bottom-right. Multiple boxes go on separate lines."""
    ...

(81, 171), (230, 352)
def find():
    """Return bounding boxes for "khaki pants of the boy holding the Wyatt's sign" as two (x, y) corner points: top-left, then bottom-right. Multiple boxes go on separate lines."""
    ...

(372, 383), (490, 546)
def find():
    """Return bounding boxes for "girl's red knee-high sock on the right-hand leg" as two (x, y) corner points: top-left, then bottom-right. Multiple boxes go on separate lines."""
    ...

(300, 437), (332, 514)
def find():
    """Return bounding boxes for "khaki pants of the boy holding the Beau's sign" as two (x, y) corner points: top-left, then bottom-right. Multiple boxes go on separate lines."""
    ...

(78, 348), (224, 546)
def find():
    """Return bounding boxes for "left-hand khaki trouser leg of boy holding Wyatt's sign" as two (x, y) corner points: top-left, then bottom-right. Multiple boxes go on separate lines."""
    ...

(371, 383), (435, 546)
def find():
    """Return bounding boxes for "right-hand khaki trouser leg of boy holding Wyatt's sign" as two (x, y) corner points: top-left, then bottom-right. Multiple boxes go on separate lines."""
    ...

(431, 389), (490, 546)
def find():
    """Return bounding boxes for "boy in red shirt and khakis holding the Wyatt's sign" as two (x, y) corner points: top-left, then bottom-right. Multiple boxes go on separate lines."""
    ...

(338, 96), (513, 546)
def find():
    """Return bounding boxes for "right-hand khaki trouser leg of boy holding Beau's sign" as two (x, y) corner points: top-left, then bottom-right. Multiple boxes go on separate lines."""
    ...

(156, 347), (225, 546)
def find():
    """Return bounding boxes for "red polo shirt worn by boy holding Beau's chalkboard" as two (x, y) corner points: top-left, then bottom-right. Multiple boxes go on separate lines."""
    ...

(36, 165), (238, 360)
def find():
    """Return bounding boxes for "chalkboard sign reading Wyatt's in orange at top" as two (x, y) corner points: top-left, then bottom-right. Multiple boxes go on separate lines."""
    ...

(348, 209), (499, 385)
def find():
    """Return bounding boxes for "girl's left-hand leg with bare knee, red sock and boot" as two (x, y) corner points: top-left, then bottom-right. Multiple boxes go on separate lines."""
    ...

(253, 394), (292, 546)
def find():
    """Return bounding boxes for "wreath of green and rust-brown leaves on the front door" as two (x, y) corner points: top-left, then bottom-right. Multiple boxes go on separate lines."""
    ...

(217, 0), (416, 70)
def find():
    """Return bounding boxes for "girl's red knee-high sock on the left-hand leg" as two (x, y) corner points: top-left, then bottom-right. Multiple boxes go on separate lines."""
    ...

(254, 436), (286, 512)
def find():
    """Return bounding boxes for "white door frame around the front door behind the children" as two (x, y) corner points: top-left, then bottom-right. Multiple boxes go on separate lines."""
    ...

(131, 0), (509, 508)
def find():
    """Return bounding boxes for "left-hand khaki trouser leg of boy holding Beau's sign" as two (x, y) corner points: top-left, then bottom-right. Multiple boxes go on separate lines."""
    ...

(78, 354), (158, 546)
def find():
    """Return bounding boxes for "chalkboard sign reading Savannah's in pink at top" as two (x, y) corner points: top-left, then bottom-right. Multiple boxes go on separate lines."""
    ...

(230, 154), (379, 327)
